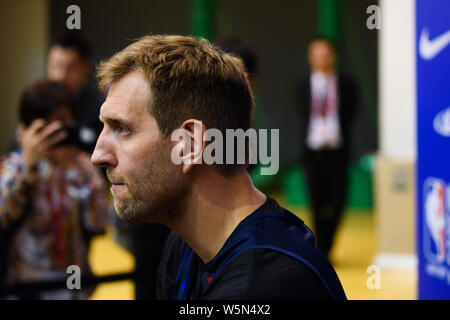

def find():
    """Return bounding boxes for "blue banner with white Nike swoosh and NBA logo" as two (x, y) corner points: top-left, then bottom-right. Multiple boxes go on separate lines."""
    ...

(416, 0), (450, 299)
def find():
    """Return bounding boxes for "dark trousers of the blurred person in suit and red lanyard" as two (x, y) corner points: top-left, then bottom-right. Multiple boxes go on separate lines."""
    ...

(305, 149), (348, 256)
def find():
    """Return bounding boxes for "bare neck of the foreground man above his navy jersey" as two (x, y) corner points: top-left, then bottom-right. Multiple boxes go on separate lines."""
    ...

(169, 169), (266, 263)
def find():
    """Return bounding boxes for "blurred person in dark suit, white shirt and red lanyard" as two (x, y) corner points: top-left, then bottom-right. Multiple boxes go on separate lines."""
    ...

(297, 37), (357, 256)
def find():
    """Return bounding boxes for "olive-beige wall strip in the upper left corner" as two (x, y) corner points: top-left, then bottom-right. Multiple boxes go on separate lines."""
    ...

(0, 0), (48, 153)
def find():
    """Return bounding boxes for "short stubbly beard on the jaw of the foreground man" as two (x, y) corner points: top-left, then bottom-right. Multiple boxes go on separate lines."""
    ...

(110, 147), (187, 224)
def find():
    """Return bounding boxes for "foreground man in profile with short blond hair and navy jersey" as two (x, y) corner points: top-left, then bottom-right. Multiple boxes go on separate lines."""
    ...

(91, 35), (345, 299)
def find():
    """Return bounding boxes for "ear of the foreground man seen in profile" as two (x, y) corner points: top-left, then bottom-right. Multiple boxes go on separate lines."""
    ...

(180, 119), (206, 173)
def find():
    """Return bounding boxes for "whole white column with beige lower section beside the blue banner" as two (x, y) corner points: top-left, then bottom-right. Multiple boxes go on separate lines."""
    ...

(375, 0), (416, 267)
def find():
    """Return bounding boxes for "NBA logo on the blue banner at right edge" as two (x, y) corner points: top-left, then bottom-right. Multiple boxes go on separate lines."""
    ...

(423, 178), (450, 264)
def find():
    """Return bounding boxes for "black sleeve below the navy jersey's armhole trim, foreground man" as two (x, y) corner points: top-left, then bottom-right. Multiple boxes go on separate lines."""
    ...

(204, 249), (330, 300)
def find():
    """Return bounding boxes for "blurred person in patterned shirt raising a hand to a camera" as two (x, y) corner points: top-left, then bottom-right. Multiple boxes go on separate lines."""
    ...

(0, 80), (110, 299)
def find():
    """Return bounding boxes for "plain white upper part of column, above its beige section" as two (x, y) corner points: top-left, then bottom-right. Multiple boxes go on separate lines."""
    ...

(379, 0), (416, 161)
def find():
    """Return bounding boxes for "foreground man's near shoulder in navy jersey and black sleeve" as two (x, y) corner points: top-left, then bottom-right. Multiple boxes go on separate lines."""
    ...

(200, 197), (338, 299)
